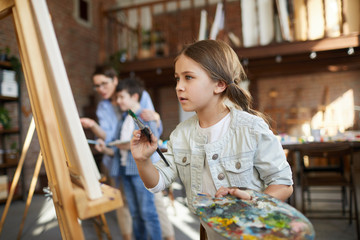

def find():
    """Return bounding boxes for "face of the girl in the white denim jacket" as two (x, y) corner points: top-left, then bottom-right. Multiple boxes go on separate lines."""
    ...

(175, 55), (218, 112)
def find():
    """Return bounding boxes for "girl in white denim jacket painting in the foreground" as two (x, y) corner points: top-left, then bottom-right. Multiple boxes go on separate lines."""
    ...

(131, 40), (293, 239)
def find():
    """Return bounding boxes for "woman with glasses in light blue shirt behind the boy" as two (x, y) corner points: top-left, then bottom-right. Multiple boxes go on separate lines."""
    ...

(80, 65), (174, 240)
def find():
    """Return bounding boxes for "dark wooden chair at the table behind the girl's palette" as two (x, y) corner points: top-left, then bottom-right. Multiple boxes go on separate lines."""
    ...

(300, 142), (360, 237)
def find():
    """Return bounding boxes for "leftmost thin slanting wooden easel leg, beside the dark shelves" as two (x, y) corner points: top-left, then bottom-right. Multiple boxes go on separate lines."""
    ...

(0, 119), (35, 234)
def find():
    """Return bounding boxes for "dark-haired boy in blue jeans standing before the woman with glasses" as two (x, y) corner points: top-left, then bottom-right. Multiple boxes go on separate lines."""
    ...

(96, 78), (162, 240)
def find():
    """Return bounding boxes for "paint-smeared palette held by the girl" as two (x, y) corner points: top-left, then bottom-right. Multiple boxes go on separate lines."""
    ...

(194, 190), (315, 240)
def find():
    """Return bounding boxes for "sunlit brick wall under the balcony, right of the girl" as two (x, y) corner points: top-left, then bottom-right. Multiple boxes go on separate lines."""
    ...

(257, 71), (360, 135)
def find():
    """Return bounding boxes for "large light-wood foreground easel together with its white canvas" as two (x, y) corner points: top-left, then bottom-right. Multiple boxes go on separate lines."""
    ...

(0, 0), (122, 239)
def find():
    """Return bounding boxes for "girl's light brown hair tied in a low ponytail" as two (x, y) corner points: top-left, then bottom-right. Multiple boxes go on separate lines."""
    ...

(175, 40), (268, 123)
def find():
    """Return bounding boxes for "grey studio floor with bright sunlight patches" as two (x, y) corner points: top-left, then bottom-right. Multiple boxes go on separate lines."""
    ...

(0, 183), (357, 240)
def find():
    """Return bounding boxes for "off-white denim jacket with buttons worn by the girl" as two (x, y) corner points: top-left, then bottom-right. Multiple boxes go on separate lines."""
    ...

(155, 108), (293, 211)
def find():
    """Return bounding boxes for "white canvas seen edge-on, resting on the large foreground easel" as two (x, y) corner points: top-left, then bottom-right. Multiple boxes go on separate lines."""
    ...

(31, 0), (102, 199)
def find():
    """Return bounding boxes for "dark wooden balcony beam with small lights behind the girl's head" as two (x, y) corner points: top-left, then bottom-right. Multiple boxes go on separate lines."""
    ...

(121, 33), (360, 83)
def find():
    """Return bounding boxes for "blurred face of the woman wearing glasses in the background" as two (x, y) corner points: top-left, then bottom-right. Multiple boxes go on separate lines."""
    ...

(93, 74), (118, 99)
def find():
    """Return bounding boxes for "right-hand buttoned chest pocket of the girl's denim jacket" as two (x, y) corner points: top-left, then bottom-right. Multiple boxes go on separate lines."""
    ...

(221, 151), (255, 187)
